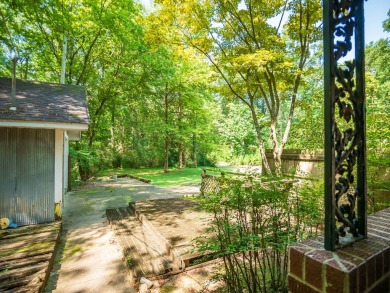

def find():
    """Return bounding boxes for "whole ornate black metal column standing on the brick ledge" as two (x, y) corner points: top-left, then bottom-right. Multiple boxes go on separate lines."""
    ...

(323, 0), (367, 250)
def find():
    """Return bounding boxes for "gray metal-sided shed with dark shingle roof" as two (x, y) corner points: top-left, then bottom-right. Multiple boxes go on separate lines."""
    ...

(0, 78), (89, 225)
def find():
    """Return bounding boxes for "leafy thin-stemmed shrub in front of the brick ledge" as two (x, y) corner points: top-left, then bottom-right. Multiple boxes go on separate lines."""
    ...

(197, 178), (323, 292)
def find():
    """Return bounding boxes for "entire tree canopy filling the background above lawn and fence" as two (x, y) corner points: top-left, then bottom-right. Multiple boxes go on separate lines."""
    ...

(0, 0), (390, 179)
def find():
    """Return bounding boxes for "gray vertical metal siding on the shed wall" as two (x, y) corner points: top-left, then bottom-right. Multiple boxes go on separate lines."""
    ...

(0, 128), (55, 225)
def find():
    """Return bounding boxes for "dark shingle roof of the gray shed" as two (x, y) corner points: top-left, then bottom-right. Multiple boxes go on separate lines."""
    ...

(0, 78), (89, 124)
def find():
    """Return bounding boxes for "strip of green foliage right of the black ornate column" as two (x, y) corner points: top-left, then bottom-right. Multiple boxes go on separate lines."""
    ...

(366, 36), (390, 211)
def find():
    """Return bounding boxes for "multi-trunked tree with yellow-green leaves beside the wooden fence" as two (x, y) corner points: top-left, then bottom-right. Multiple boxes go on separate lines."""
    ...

(157, 0), (321, 173)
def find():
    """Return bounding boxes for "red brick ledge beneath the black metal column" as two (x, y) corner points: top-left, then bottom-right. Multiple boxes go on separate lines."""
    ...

(288, 209), (390, 293)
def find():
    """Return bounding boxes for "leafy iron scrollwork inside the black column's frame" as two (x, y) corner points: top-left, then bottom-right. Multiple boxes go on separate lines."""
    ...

(330, 0), (365, 244)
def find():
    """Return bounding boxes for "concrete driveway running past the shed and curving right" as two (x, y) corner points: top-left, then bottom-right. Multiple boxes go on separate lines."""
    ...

(46, 179), (199, 293)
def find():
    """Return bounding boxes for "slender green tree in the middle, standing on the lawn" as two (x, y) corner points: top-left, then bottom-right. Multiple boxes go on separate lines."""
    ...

(146, 5), (216, 172)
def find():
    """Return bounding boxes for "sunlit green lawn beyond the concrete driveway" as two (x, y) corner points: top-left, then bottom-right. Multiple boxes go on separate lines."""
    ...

(99, 167), (232, 187)
